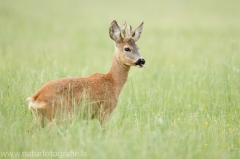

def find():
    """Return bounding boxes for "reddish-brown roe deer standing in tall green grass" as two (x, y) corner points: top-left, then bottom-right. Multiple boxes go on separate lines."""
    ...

(27, 20), (145, 129)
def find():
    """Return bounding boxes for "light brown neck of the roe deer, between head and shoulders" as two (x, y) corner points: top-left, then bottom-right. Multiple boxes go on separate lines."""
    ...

(108, 53), (130, 96)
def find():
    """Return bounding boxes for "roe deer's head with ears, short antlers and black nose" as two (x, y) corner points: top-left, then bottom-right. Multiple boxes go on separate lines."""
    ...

(109, 20), (145, 68)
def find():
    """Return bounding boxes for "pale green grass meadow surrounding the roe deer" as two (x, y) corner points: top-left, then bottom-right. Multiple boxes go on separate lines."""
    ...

(0, 0), (240, 159)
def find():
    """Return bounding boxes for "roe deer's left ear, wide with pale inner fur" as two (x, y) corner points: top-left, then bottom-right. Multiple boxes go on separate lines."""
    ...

(109, 20), (122, 42)
